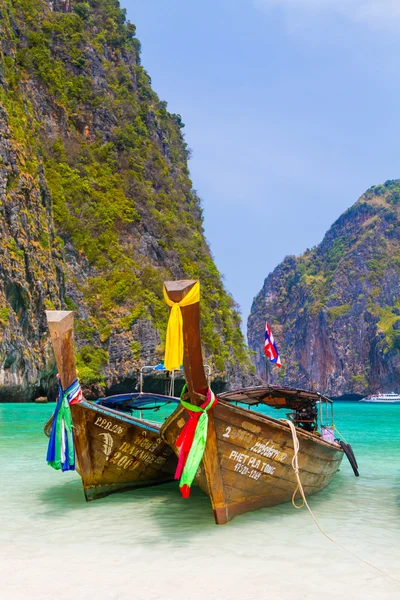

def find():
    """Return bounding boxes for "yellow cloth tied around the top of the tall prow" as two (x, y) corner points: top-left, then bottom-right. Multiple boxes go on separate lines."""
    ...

(164, 281), (200, 371)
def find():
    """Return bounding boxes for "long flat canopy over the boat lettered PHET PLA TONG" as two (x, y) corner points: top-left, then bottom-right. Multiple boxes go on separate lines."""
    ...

(218, 385), (331, 408)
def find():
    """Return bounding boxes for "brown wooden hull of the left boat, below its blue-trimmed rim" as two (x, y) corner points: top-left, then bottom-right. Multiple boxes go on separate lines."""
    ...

(45, 400), (177, 501)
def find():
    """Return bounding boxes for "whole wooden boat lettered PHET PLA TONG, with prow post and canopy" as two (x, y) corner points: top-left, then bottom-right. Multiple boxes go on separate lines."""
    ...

(161, 281), (343, 524)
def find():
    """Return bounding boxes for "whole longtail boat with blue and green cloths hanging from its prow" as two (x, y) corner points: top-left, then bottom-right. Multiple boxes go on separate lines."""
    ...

(45, 311), (177, 501)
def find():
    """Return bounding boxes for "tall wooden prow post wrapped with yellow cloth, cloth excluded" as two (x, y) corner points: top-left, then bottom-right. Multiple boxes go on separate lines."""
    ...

(164, 279), (208, 404)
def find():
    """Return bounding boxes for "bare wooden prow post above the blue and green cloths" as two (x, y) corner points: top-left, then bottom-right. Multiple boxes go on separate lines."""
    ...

(46, 310), (76, 390)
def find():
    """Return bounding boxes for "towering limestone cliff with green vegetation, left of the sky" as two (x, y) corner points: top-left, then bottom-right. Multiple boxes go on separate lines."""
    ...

(0, 0), (250, 399)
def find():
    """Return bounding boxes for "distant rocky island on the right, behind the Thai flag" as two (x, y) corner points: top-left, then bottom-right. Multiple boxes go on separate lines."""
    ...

(248, 180), (400, 396)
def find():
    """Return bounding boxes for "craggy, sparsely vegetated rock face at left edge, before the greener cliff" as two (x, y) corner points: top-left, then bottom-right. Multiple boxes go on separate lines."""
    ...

(0, 105), (64, 401)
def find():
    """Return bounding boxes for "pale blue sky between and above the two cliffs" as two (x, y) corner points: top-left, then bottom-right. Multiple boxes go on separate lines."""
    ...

(122, 0), (400, 332)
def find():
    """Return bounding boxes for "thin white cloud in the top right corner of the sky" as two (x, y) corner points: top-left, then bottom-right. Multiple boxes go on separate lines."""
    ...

(255, 0), (400, 29)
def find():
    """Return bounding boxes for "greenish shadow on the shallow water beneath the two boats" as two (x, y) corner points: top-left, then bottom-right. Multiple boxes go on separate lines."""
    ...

(38, 474), (354, 547)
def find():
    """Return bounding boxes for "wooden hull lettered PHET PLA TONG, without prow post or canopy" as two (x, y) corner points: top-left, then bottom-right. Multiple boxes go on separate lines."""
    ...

(161, 401), (343, 524)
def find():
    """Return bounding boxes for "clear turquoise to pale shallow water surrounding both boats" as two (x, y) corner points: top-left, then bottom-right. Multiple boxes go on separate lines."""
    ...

(0, 403), (400, 600)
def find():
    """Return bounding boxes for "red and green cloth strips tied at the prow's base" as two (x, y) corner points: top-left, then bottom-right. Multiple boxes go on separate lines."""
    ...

(175, 384), (217, 498)
